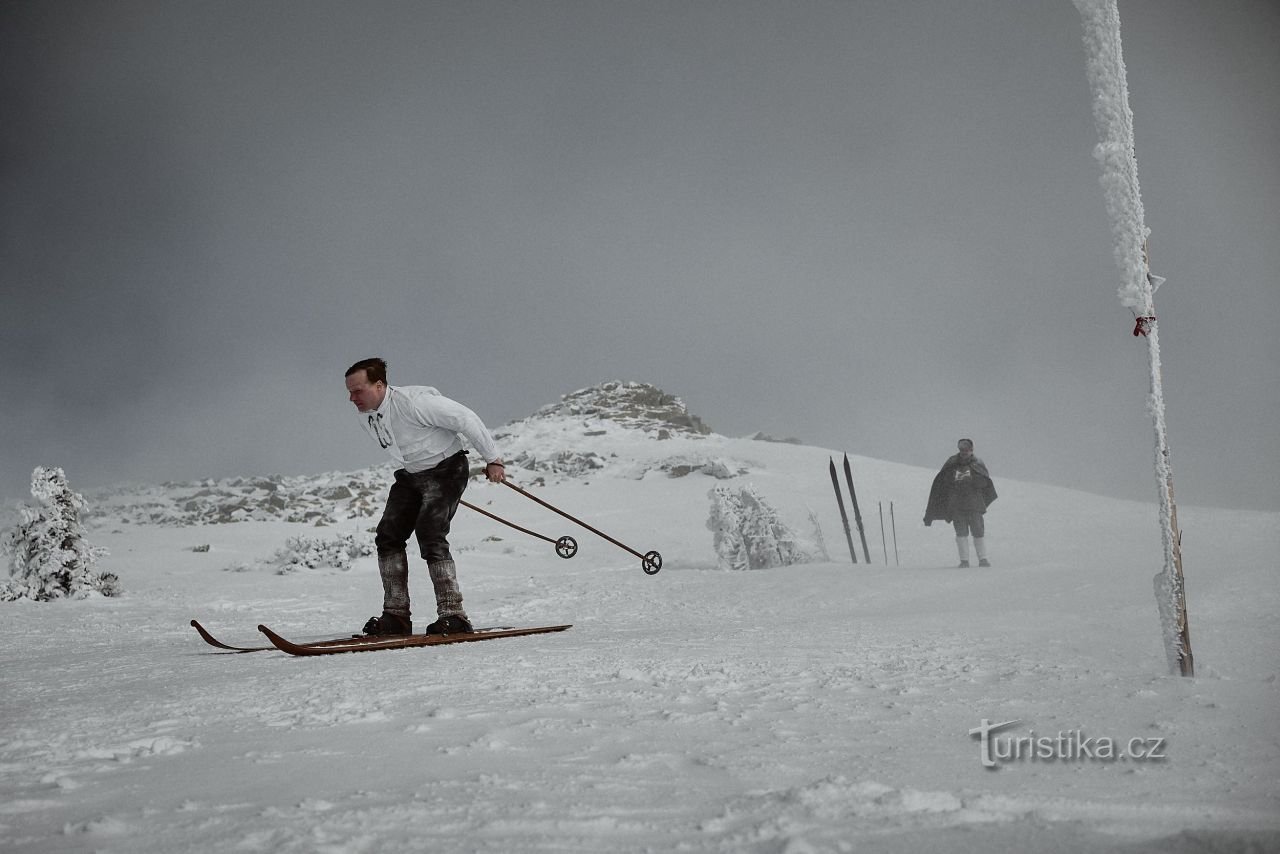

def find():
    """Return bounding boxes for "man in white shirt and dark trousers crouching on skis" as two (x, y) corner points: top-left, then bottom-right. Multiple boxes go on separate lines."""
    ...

(347, 359), (506, 635)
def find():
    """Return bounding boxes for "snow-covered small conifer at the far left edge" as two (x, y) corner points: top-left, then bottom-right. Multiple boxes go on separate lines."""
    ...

(0, 466), (120, 602)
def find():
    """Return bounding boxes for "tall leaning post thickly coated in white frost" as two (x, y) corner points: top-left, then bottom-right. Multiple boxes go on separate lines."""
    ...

(1073, 0), (1196, 676)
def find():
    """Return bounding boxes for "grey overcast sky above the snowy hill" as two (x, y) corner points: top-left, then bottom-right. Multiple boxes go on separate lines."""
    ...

(0, 0), (1280, 512)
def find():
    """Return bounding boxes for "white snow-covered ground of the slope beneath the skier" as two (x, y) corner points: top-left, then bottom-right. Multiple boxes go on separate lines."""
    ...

(0, 396), (1280, 853)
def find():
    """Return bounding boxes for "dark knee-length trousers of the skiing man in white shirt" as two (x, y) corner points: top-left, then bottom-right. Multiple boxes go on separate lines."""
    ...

(374, 451), (470, 563)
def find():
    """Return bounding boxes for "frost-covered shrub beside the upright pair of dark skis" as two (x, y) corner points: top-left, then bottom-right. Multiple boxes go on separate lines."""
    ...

(707, 485), (809, 570)
